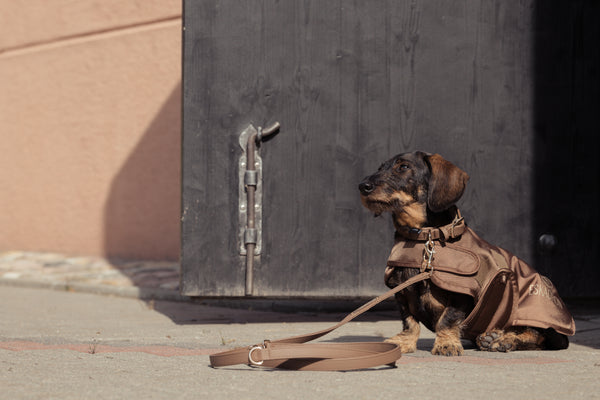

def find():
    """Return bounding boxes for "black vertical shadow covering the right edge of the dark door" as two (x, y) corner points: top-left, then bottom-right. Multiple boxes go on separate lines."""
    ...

(532, 0), (600, 298)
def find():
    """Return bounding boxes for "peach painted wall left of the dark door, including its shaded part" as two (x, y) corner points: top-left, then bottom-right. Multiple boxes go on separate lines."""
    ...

(0, 0), (181, 260)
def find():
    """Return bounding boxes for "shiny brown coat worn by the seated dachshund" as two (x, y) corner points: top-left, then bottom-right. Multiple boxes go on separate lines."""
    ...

(386, 210), (575, 339)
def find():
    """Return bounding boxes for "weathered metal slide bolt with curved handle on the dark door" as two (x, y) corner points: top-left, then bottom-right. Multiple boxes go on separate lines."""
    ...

(238, 122), (280, 296)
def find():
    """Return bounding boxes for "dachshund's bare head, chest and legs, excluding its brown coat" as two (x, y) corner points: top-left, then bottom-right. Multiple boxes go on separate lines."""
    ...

(359, 151), (574, 356)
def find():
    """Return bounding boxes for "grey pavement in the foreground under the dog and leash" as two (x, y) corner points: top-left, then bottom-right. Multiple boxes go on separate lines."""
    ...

(0, 252), (600, 400)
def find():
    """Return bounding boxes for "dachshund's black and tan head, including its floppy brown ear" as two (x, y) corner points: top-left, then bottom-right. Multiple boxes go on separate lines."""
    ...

(358, 151), (469, 228)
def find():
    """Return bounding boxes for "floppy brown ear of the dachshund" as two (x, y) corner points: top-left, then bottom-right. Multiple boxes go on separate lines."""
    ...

(424, 154), (469, 212)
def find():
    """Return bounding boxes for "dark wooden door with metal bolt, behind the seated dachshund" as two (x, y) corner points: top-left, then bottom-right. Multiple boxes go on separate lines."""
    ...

(182, 0), (599, 298)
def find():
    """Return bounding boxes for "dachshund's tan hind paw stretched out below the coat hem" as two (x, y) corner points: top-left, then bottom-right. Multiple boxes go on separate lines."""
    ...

(476, 327), (544, 352)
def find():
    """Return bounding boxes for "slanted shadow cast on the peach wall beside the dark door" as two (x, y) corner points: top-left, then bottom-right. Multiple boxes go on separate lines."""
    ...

(104, 82), (181, 262)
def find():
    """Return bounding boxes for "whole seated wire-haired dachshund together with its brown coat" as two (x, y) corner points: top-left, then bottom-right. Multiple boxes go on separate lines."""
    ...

(359, 151), (575, 356)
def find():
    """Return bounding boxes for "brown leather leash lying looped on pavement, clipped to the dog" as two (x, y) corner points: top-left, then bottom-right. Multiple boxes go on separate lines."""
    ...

(210, 271), (432, 371)
